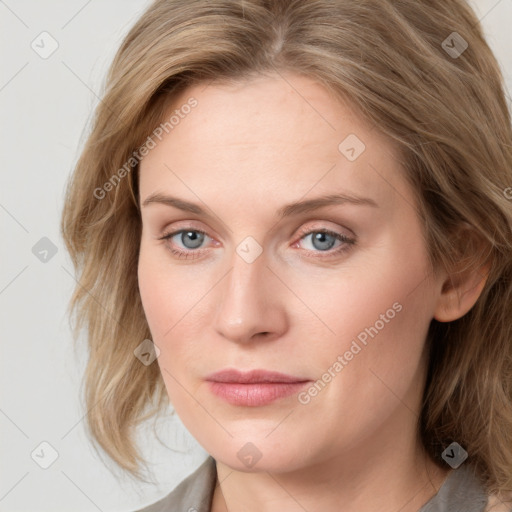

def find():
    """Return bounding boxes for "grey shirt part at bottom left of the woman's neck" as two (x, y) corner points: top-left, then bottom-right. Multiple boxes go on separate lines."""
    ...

(132, 456), (217, 512)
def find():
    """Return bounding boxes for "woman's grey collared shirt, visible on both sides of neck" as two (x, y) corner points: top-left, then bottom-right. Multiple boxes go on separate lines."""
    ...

(137, 456), (487, 512)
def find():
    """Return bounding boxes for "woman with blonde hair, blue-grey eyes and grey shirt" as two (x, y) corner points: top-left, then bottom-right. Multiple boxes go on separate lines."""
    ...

(62, 0), (512, 512)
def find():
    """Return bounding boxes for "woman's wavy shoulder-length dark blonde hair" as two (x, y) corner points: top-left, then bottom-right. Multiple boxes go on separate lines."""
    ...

(61, 0), (512, 492)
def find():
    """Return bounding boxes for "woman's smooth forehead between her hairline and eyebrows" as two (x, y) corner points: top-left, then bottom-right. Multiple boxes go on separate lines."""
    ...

(141, 74), (407, 214)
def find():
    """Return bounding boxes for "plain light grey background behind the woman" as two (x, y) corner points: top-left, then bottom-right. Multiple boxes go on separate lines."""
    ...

(0, 0), (512, 512)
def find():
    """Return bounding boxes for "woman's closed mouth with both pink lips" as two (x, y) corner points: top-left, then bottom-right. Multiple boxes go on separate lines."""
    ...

(206, 369), (311, 407)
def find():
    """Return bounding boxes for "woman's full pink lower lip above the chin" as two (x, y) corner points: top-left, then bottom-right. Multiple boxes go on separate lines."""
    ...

(208, 381), (309, 407)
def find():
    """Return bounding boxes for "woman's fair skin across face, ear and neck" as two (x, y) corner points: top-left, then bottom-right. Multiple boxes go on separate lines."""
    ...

(138, 73), (490, 512)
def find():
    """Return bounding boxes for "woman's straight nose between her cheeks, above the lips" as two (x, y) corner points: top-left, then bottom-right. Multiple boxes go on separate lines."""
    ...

(215, 245), (288, 344)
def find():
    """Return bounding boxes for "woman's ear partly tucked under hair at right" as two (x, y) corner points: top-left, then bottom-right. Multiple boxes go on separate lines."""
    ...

(434, 225), (491, 322)
